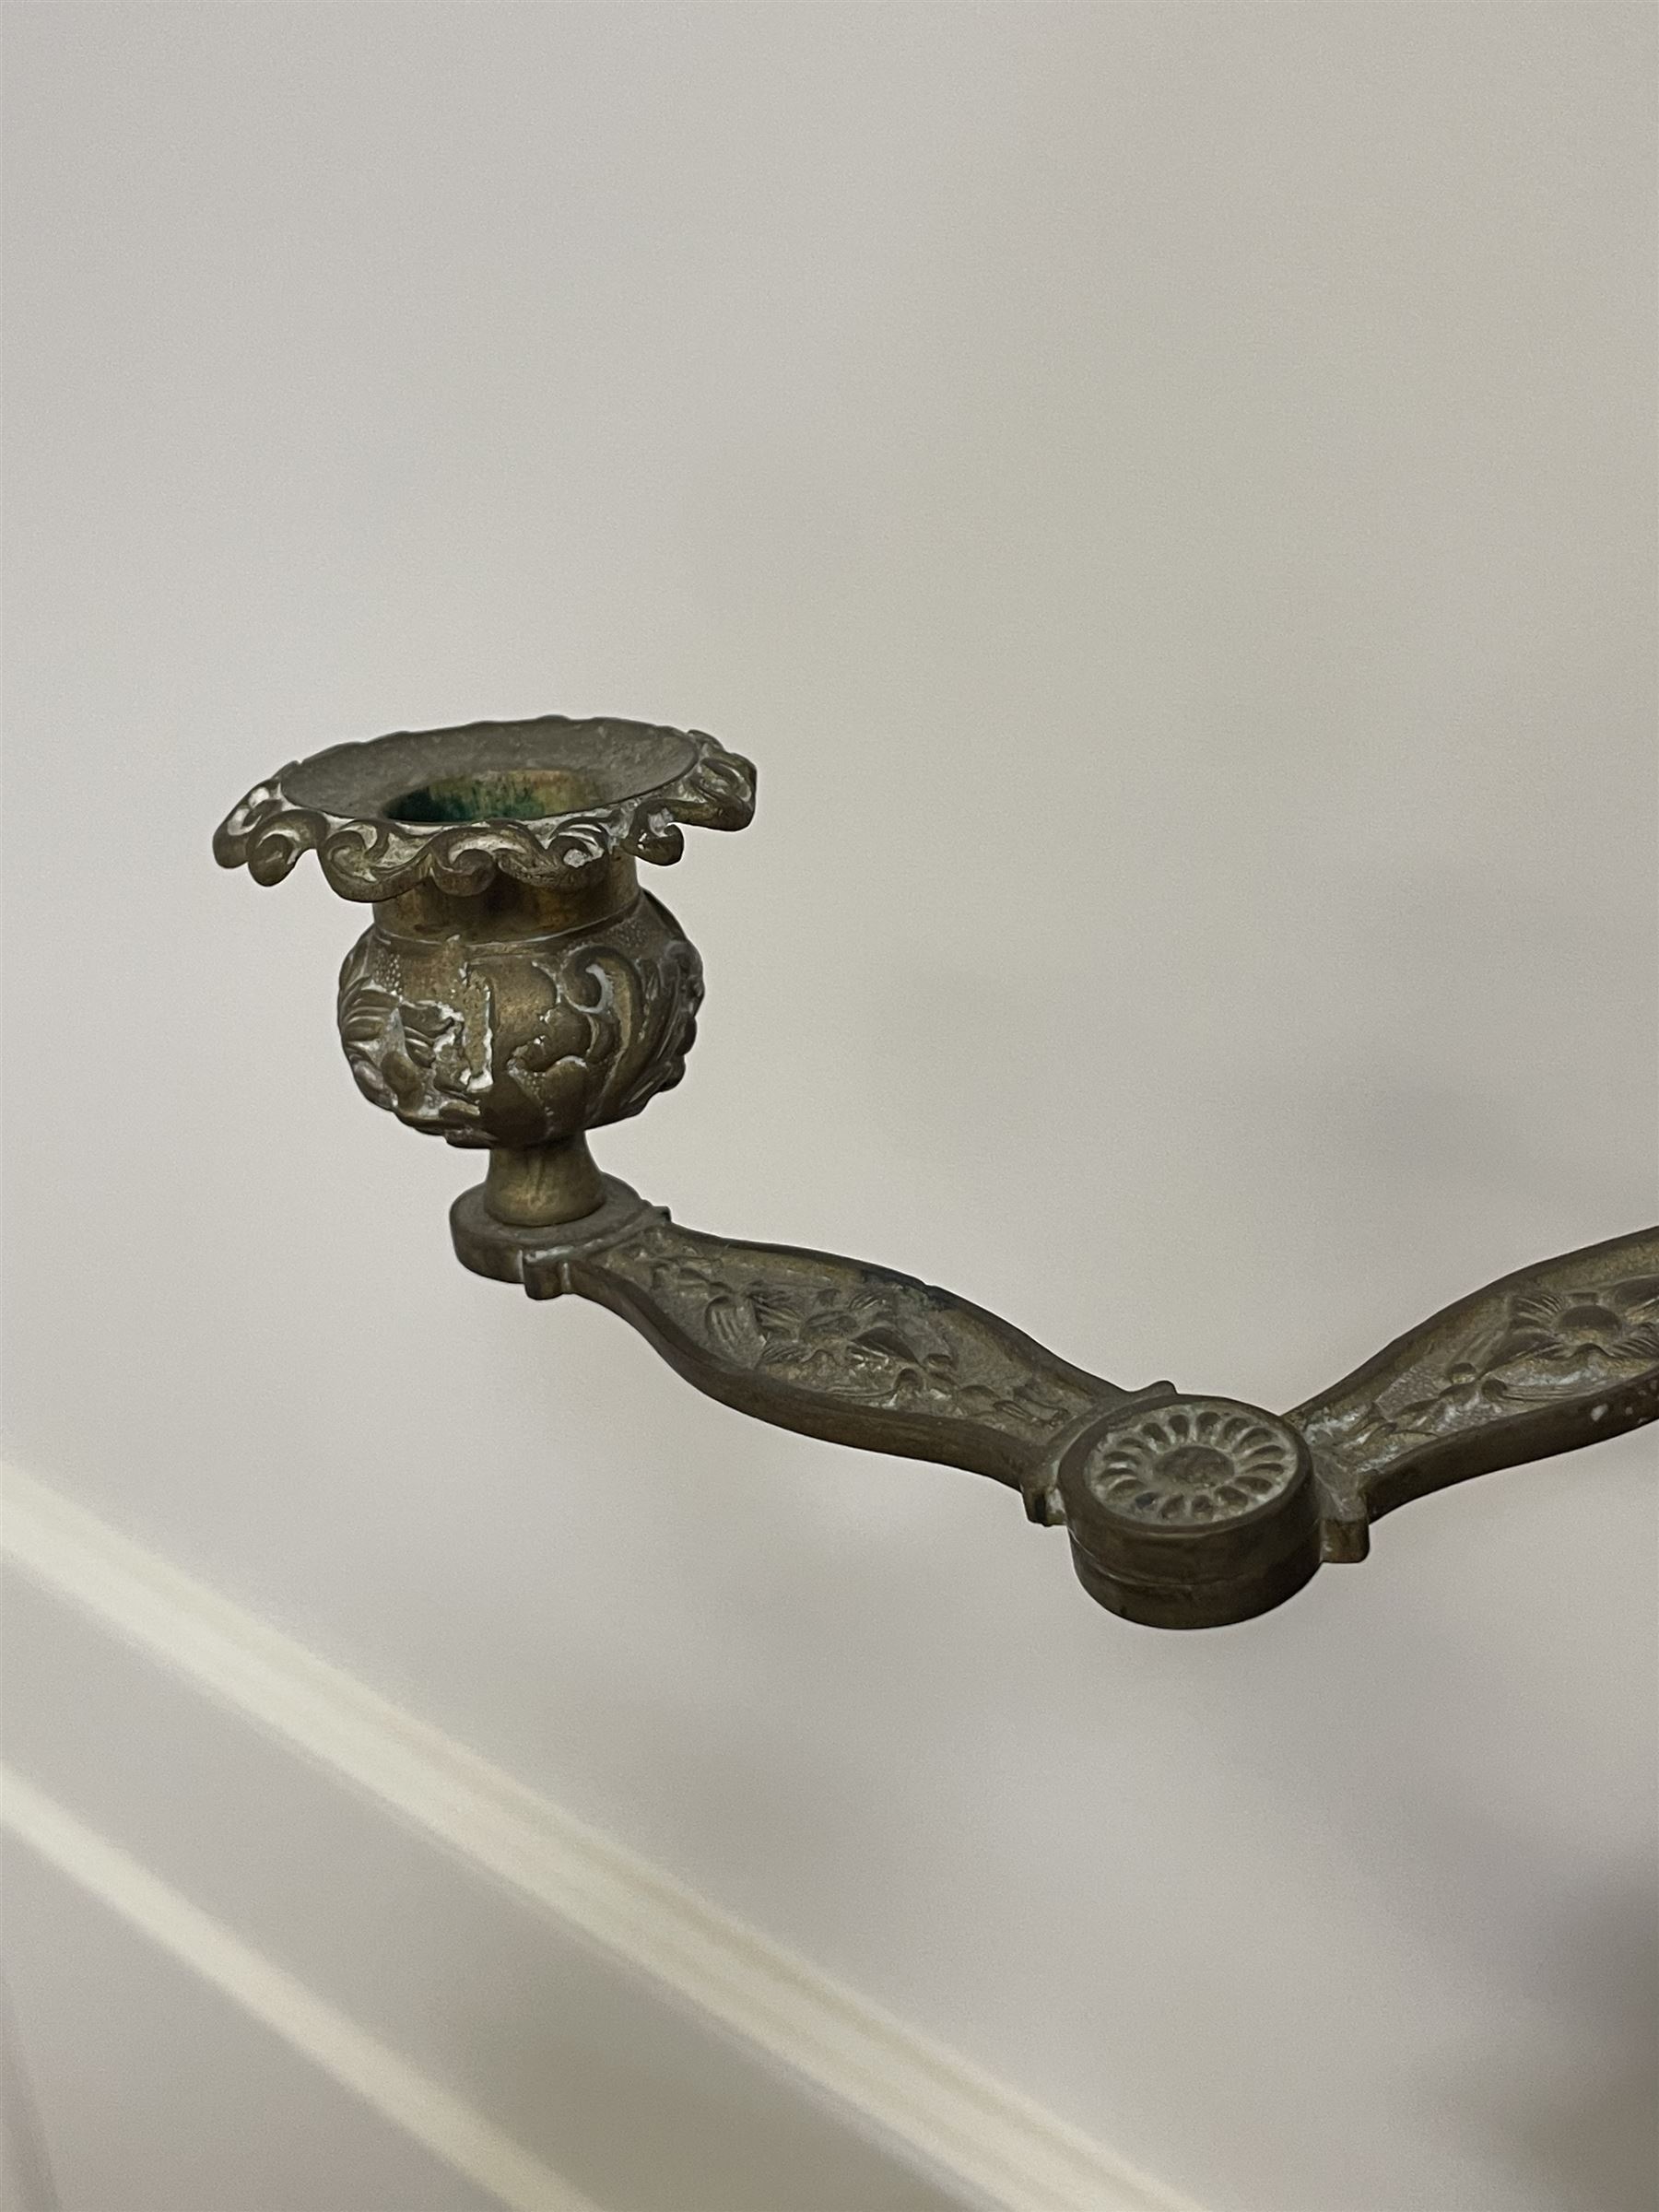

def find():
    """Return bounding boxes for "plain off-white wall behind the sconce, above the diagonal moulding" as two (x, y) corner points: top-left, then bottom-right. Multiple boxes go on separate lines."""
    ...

(5, 17), (1659, 2212)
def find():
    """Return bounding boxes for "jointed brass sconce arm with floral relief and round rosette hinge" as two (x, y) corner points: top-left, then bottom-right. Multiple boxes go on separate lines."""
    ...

(452, 1177), (1659, 1628)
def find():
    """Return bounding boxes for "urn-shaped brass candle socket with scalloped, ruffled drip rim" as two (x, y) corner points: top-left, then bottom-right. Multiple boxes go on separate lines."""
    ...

(215, 717), (754, 1228)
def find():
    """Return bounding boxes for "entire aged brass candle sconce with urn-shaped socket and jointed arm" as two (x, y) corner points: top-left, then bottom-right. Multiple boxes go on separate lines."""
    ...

(215, 714), (1659, 1628)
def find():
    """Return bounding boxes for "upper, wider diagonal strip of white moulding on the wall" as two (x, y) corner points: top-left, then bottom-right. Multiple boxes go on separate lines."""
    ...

(0, 1469), (1196, 2212)
